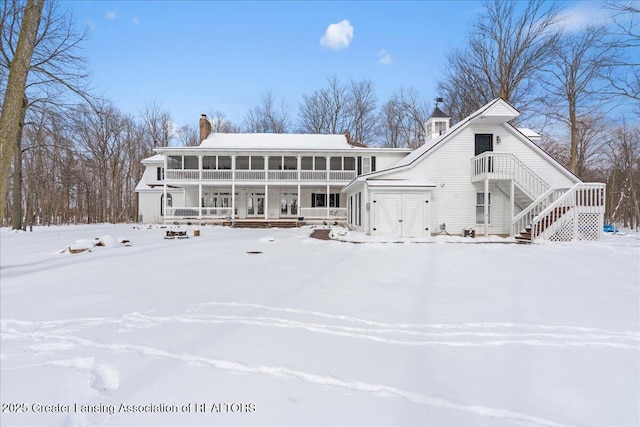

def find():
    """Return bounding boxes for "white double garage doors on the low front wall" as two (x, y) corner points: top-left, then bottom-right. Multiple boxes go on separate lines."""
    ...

(371, 193), (430, 237)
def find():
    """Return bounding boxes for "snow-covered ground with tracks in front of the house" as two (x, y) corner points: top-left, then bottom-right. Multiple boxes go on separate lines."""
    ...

(0, 225), (640, 426)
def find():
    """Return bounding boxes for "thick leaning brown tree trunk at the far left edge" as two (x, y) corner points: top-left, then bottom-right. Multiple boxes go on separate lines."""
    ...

(0, 0), (44, 226)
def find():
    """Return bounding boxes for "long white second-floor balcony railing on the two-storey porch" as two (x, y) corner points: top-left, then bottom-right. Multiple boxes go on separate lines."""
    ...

(166, 169), (356, 182)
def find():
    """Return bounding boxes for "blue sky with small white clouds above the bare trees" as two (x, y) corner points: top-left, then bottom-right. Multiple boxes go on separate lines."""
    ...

(60, 0), (616, 130)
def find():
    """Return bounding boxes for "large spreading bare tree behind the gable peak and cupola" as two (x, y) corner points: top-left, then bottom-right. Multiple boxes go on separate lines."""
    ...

(438, 0), (560, 121)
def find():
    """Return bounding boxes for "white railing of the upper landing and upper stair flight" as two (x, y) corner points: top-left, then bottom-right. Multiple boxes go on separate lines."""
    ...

(471, 151), (551, 200)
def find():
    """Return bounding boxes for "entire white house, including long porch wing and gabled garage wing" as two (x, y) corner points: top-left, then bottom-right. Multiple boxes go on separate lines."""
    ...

(136, 99), (605, 242)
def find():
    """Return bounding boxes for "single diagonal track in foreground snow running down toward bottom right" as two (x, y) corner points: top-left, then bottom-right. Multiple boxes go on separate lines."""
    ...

(3, 321), (562, 427)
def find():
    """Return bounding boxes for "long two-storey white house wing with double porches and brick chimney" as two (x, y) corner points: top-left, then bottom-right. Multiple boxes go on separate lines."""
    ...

(136, 123), (411, 225)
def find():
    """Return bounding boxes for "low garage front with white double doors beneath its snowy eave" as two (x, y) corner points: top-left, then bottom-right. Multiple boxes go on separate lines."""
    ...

(367, 180), (435, 238)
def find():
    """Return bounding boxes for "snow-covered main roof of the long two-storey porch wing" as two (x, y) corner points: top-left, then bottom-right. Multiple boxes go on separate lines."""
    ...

(200, 133), (354, 150)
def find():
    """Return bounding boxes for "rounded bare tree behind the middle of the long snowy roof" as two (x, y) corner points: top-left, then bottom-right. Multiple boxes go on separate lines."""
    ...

(244, 91), (290, 133)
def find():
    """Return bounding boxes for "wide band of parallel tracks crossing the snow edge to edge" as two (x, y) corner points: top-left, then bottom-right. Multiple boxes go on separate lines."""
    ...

(2, 313), (640, 351)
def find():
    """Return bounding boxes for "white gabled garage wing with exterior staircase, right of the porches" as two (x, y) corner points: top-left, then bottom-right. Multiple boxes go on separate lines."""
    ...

(343, 99), (605, 241)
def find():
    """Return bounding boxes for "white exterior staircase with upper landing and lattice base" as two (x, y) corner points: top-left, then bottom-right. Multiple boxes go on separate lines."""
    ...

(472, 151), (606, 243)
